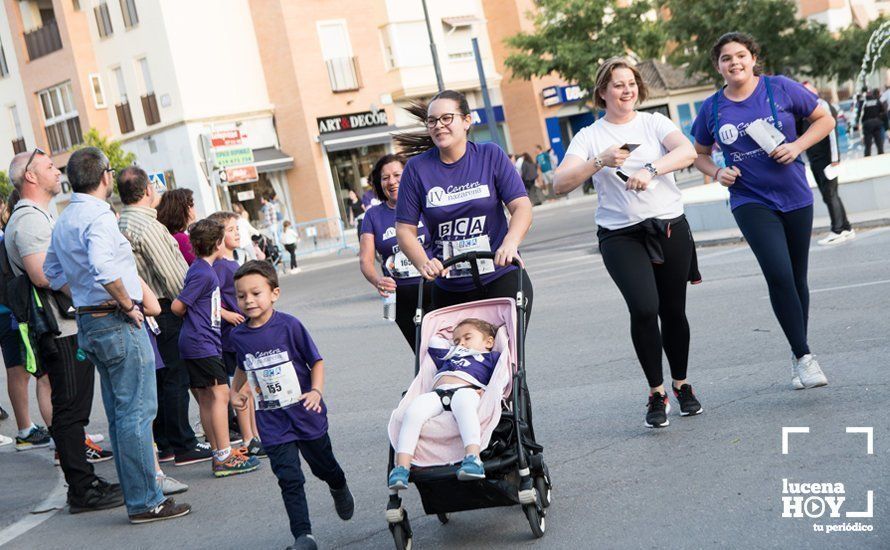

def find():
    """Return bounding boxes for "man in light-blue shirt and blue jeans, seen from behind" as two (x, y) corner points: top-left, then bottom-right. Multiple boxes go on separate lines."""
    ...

(43, 147), (191, 523)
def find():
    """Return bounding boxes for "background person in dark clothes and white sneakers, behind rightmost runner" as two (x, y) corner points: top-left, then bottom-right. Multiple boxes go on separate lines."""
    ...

(797, 81), (856, 246)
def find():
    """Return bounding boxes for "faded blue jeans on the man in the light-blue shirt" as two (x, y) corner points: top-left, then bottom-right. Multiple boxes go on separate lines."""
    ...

(77, 312), (164, 515)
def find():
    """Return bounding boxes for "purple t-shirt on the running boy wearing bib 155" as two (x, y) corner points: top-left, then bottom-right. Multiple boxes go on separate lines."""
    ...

(231, 311), (328, 445)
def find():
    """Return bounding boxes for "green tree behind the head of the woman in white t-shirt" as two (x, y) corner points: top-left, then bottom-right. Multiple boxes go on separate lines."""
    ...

(505, 0), (667, 105)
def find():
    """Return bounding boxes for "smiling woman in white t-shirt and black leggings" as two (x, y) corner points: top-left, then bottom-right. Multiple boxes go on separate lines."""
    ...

(554, 57), (702, 428)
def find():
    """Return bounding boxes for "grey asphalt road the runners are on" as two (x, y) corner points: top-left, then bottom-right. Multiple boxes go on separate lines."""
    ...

(0, 199), (890, 550)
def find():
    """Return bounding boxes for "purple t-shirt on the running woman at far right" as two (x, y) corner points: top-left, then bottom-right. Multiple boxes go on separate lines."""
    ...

(692, 76), (818, 212)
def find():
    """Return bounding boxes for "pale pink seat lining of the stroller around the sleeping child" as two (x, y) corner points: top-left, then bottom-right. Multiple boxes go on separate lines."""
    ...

(389, 298), (516, 467)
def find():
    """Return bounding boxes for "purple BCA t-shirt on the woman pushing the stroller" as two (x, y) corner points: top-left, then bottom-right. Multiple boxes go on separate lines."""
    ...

(396, 141), (528, 291)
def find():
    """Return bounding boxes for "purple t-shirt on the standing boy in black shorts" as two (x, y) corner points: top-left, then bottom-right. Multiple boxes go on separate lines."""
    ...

(177, 258), (222, 359)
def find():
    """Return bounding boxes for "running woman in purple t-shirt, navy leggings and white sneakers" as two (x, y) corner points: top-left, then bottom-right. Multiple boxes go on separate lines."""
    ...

(692, 32), (834, 389)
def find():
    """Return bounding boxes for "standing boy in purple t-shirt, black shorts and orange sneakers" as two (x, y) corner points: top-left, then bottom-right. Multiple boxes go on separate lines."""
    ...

(170, 219), (259, 477)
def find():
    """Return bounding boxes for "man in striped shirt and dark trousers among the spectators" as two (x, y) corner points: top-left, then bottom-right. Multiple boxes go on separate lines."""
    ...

(117, 166), (211, 465)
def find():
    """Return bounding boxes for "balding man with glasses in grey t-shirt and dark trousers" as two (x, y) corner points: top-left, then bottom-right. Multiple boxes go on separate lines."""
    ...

(4, 149), (123, 513)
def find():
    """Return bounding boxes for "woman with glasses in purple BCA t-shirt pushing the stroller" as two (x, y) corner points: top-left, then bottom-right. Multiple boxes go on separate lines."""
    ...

(396, 90), (532, 318)
